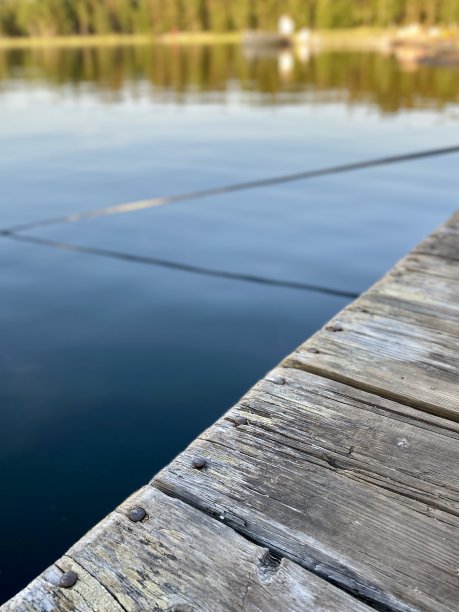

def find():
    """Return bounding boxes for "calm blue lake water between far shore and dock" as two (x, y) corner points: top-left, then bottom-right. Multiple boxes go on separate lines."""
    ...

(0, 46), (459, 600)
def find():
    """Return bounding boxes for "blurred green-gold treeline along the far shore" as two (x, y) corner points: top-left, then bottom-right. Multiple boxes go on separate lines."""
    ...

(0, 0), (459, 36)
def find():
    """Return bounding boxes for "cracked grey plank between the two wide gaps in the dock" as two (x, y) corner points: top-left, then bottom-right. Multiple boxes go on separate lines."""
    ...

(153, 368), (459, 612)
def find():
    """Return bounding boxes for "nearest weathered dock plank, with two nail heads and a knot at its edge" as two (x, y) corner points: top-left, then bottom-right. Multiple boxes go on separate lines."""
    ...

(2, 486), (370, 612)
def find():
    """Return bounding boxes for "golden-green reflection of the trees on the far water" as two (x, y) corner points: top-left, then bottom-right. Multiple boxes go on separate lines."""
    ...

(0, 45), (459, 113)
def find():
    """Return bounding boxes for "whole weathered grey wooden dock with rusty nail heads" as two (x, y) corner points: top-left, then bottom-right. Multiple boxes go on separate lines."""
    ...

(2, 213), (459, 612)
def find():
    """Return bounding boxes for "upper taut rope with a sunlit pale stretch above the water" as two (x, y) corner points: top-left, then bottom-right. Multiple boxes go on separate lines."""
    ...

(0, 145), (459, 234)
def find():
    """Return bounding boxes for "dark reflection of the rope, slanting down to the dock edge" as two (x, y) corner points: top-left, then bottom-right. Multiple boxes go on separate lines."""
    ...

(3, 232), (359, 299)
